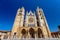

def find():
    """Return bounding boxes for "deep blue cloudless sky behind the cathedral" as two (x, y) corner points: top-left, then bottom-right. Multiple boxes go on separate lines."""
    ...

(0, 0), (60, 32)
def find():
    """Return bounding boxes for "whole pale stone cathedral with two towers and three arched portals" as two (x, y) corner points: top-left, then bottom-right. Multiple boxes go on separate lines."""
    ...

(11, 7), (51, 38)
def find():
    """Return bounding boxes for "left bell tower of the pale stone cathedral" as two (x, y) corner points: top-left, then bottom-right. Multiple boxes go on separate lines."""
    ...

(12, 7), (25, 35)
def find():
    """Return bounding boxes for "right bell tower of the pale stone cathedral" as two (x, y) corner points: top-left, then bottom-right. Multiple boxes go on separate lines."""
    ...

(36, 7), (51, 37)
